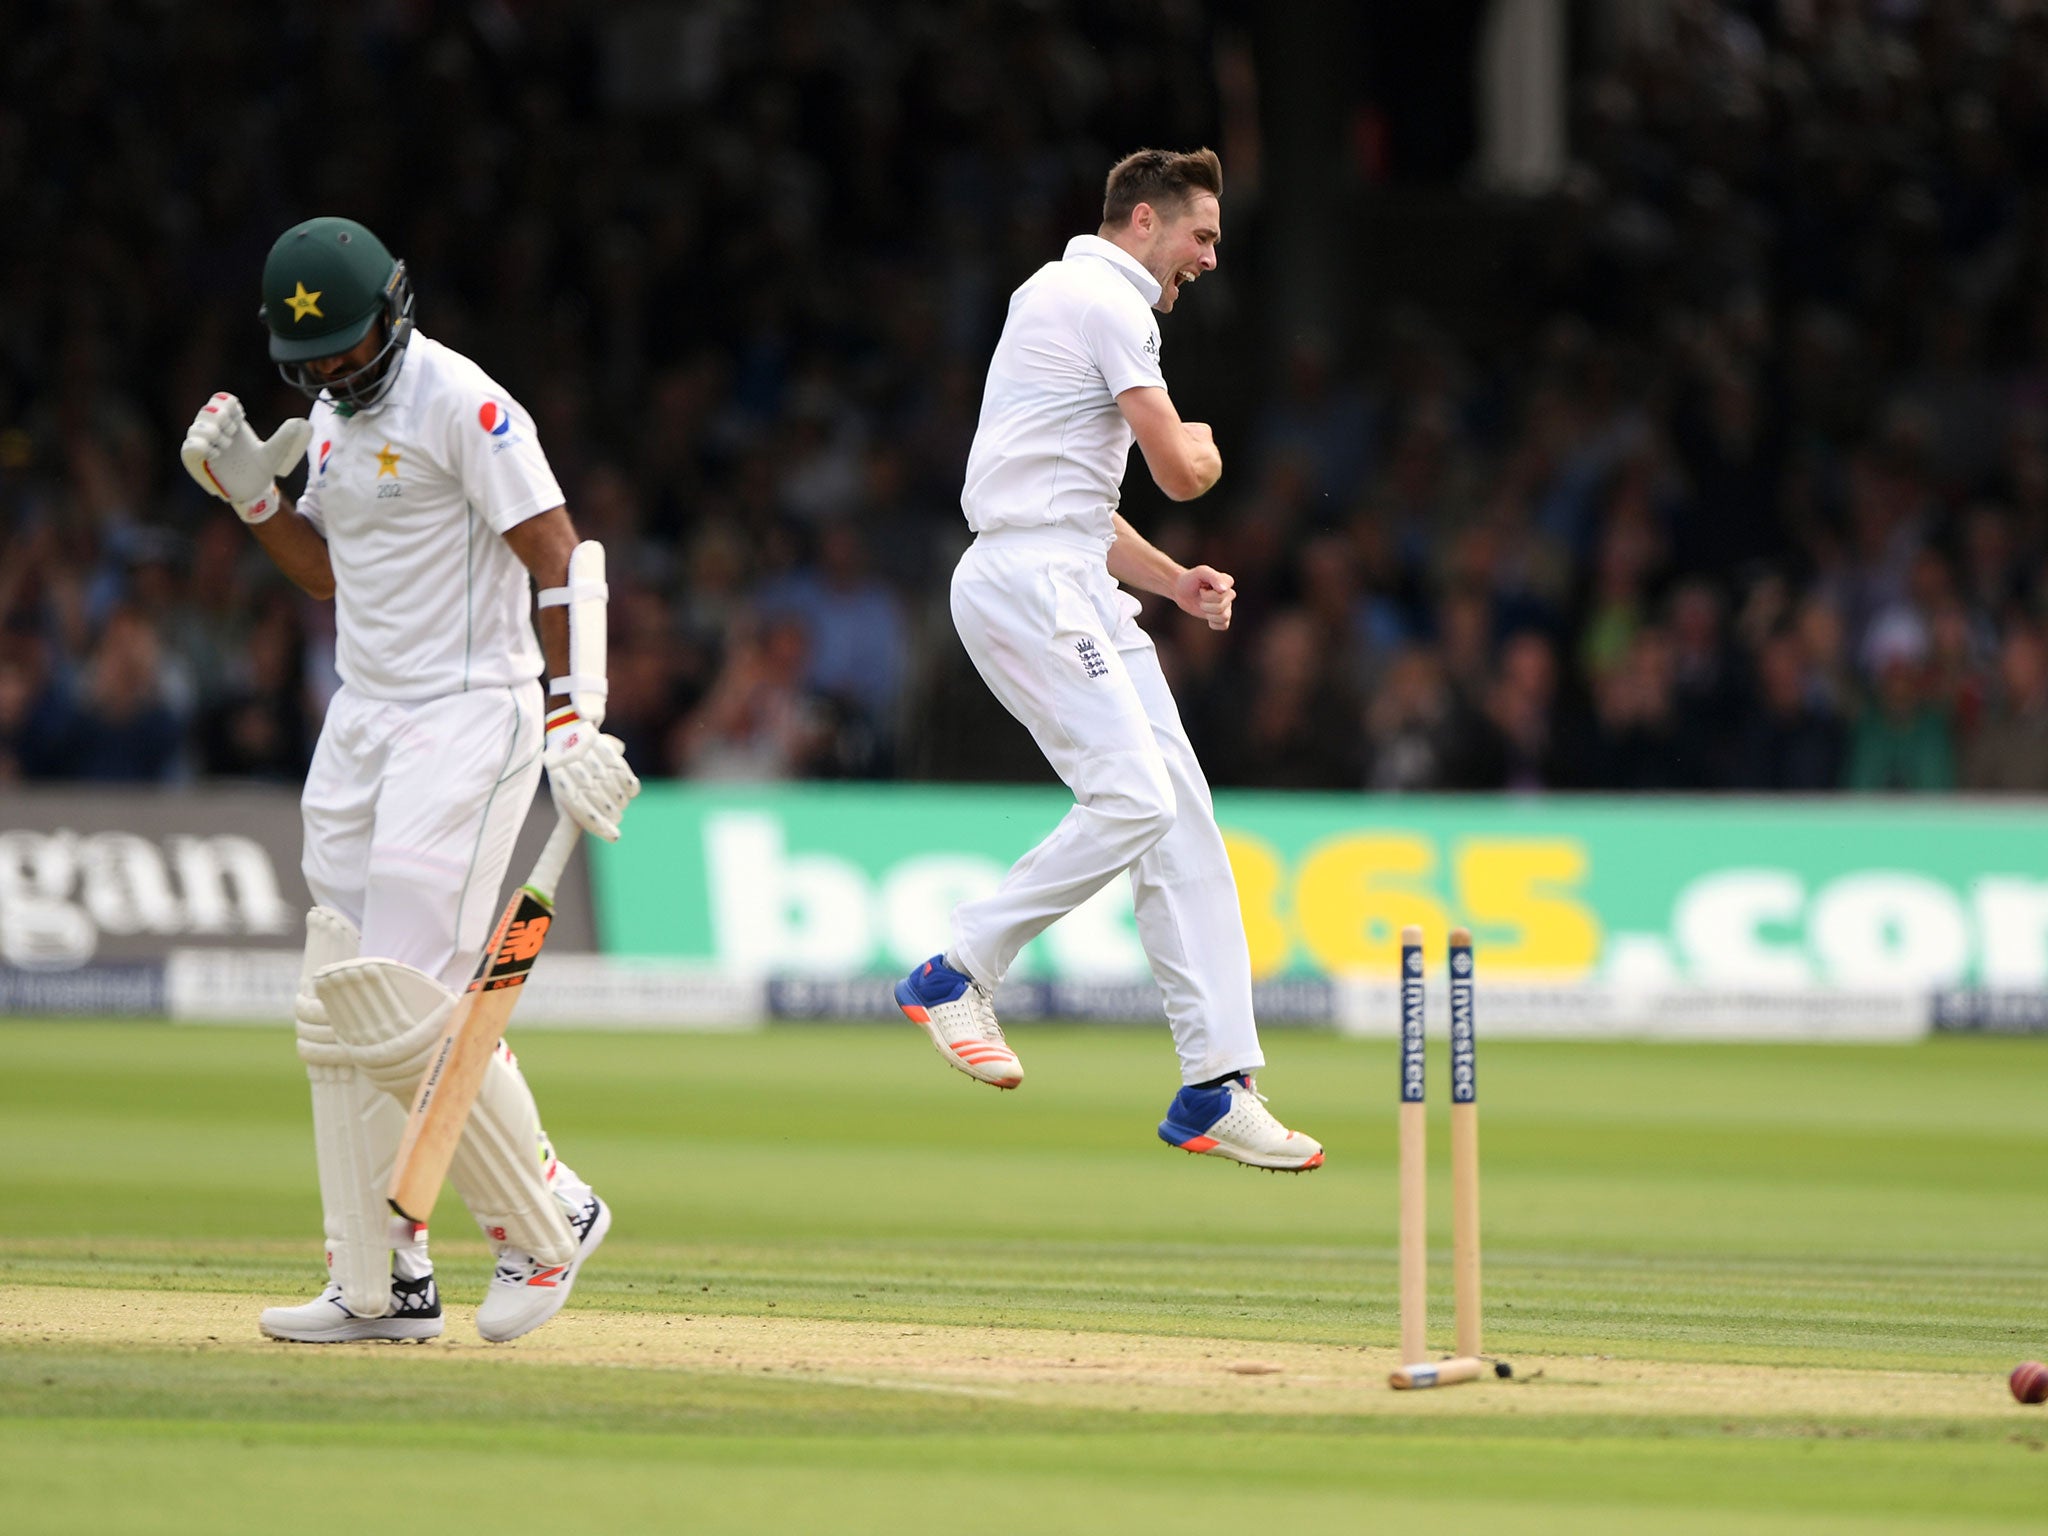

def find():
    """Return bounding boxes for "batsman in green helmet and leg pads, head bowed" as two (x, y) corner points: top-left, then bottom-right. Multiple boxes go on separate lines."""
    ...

(182, 217), (639, 1343)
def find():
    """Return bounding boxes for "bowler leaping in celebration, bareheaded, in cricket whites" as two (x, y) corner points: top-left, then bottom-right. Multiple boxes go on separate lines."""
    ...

(895, 150), (1323, 1171)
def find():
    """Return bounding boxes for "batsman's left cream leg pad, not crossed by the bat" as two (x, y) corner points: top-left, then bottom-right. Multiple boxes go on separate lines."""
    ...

(293, 907), (406, 1317)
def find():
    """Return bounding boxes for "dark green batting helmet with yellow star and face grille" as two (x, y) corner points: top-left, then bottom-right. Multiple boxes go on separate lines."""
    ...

(258, 217), (412, 412)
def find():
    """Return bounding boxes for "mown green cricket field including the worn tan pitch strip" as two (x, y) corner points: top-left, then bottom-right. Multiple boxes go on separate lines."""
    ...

(0, 1022), (2048, 1536)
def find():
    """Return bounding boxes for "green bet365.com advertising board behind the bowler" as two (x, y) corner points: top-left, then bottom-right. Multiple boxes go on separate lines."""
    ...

(594, 784), (2048, 991)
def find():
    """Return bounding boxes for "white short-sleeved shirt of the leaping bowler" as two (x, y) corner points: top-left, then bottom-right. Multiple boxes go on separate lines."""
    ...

(961, 236), (1165, 541)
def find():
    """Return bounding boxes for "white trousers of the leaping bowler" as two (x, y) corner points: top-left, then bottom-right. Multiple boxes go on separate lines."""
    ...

(948, 526), (1266, 1083)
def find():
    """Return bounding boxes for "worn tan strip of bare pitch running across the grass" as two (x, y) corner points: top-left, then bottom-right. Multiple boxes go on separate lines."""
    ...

(0, 1286), (2048, 1427)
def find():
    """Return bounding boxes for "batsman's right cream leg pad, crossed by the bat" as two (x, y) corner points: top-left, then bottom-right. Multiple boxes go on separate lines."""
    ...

(313, 958), (575, 1264)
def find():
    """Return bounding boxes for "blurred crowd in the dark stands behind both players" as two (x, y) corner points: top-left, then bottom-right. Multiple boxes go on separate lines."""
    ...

(12, 0), (2048, 791)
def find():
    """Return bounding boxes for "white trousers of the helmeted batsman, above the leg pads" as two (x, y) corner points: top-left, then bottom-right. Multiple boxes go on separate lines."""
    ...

(299, 682), (543, 991)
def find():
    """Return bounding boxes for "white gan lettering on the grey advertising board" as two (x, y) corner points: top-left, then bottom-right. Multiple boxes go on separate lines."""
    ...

(0, 827), (295, 971)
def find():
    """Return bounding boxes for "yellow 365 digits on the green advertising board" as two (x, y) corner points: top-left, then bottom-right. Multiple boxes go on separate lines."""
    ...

(1223, 829), (1602, 977)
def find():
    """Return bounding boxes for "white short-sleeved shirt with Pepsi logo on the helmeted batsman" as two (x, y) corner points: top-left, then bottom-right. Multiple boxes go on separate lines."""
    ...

(299, 332), (563, 700)
